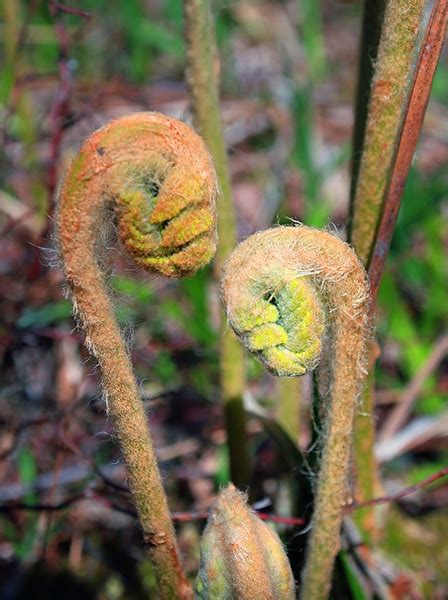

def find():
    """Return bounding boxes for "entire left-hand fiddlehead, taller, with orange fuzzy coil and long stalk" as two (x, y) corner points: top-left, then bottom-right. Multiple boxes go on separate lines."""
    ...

(57, 113), (216, 599)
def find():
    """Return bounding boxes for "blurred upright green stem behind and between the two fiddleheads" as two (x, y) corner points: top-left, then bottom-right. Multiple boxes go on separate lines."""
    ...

(184, 0), (250, 488)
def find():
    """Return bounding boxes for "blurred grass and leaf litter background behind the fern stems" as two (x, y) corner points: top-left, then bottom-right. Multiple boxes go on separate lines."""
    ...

(0, 0), (448, 599)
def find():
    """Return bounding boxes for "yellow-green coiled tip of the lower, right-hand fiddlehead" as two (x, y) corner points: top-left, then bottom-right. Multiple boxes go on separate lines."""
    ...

(221, 228), (325, 377)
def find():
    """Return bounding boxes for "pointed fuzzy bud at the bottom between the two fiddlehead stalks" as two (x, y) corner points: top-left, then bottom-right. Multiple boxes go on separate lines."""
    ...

(196, 484), (295, 600)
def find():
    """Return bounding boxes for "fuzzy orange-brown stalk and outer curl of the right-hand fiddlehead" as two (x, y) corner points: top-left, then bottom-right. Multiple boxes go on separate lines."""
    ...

(222, 226), (371, 600)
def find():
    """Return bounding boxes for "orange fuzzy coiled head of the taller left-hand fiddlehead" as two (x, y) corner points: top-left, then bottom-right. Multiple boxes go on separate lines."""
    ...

(59, 112), (217, 277)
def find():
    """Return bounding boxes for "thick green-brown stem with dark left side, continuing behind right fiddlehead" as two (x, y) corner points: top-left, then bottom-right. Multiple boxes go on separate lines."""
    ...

(349, 0), (427, 540)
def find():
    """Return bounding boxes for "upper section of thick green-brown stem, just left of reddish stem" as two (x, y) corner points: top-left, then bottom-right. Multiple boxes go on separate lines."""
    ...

(351, 0), (427, 266)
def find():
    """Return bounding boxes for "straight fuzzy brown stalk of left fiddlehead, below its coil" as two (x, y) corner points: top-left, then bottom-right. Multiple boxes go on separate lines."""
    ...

(72, 264), (192, 600)
